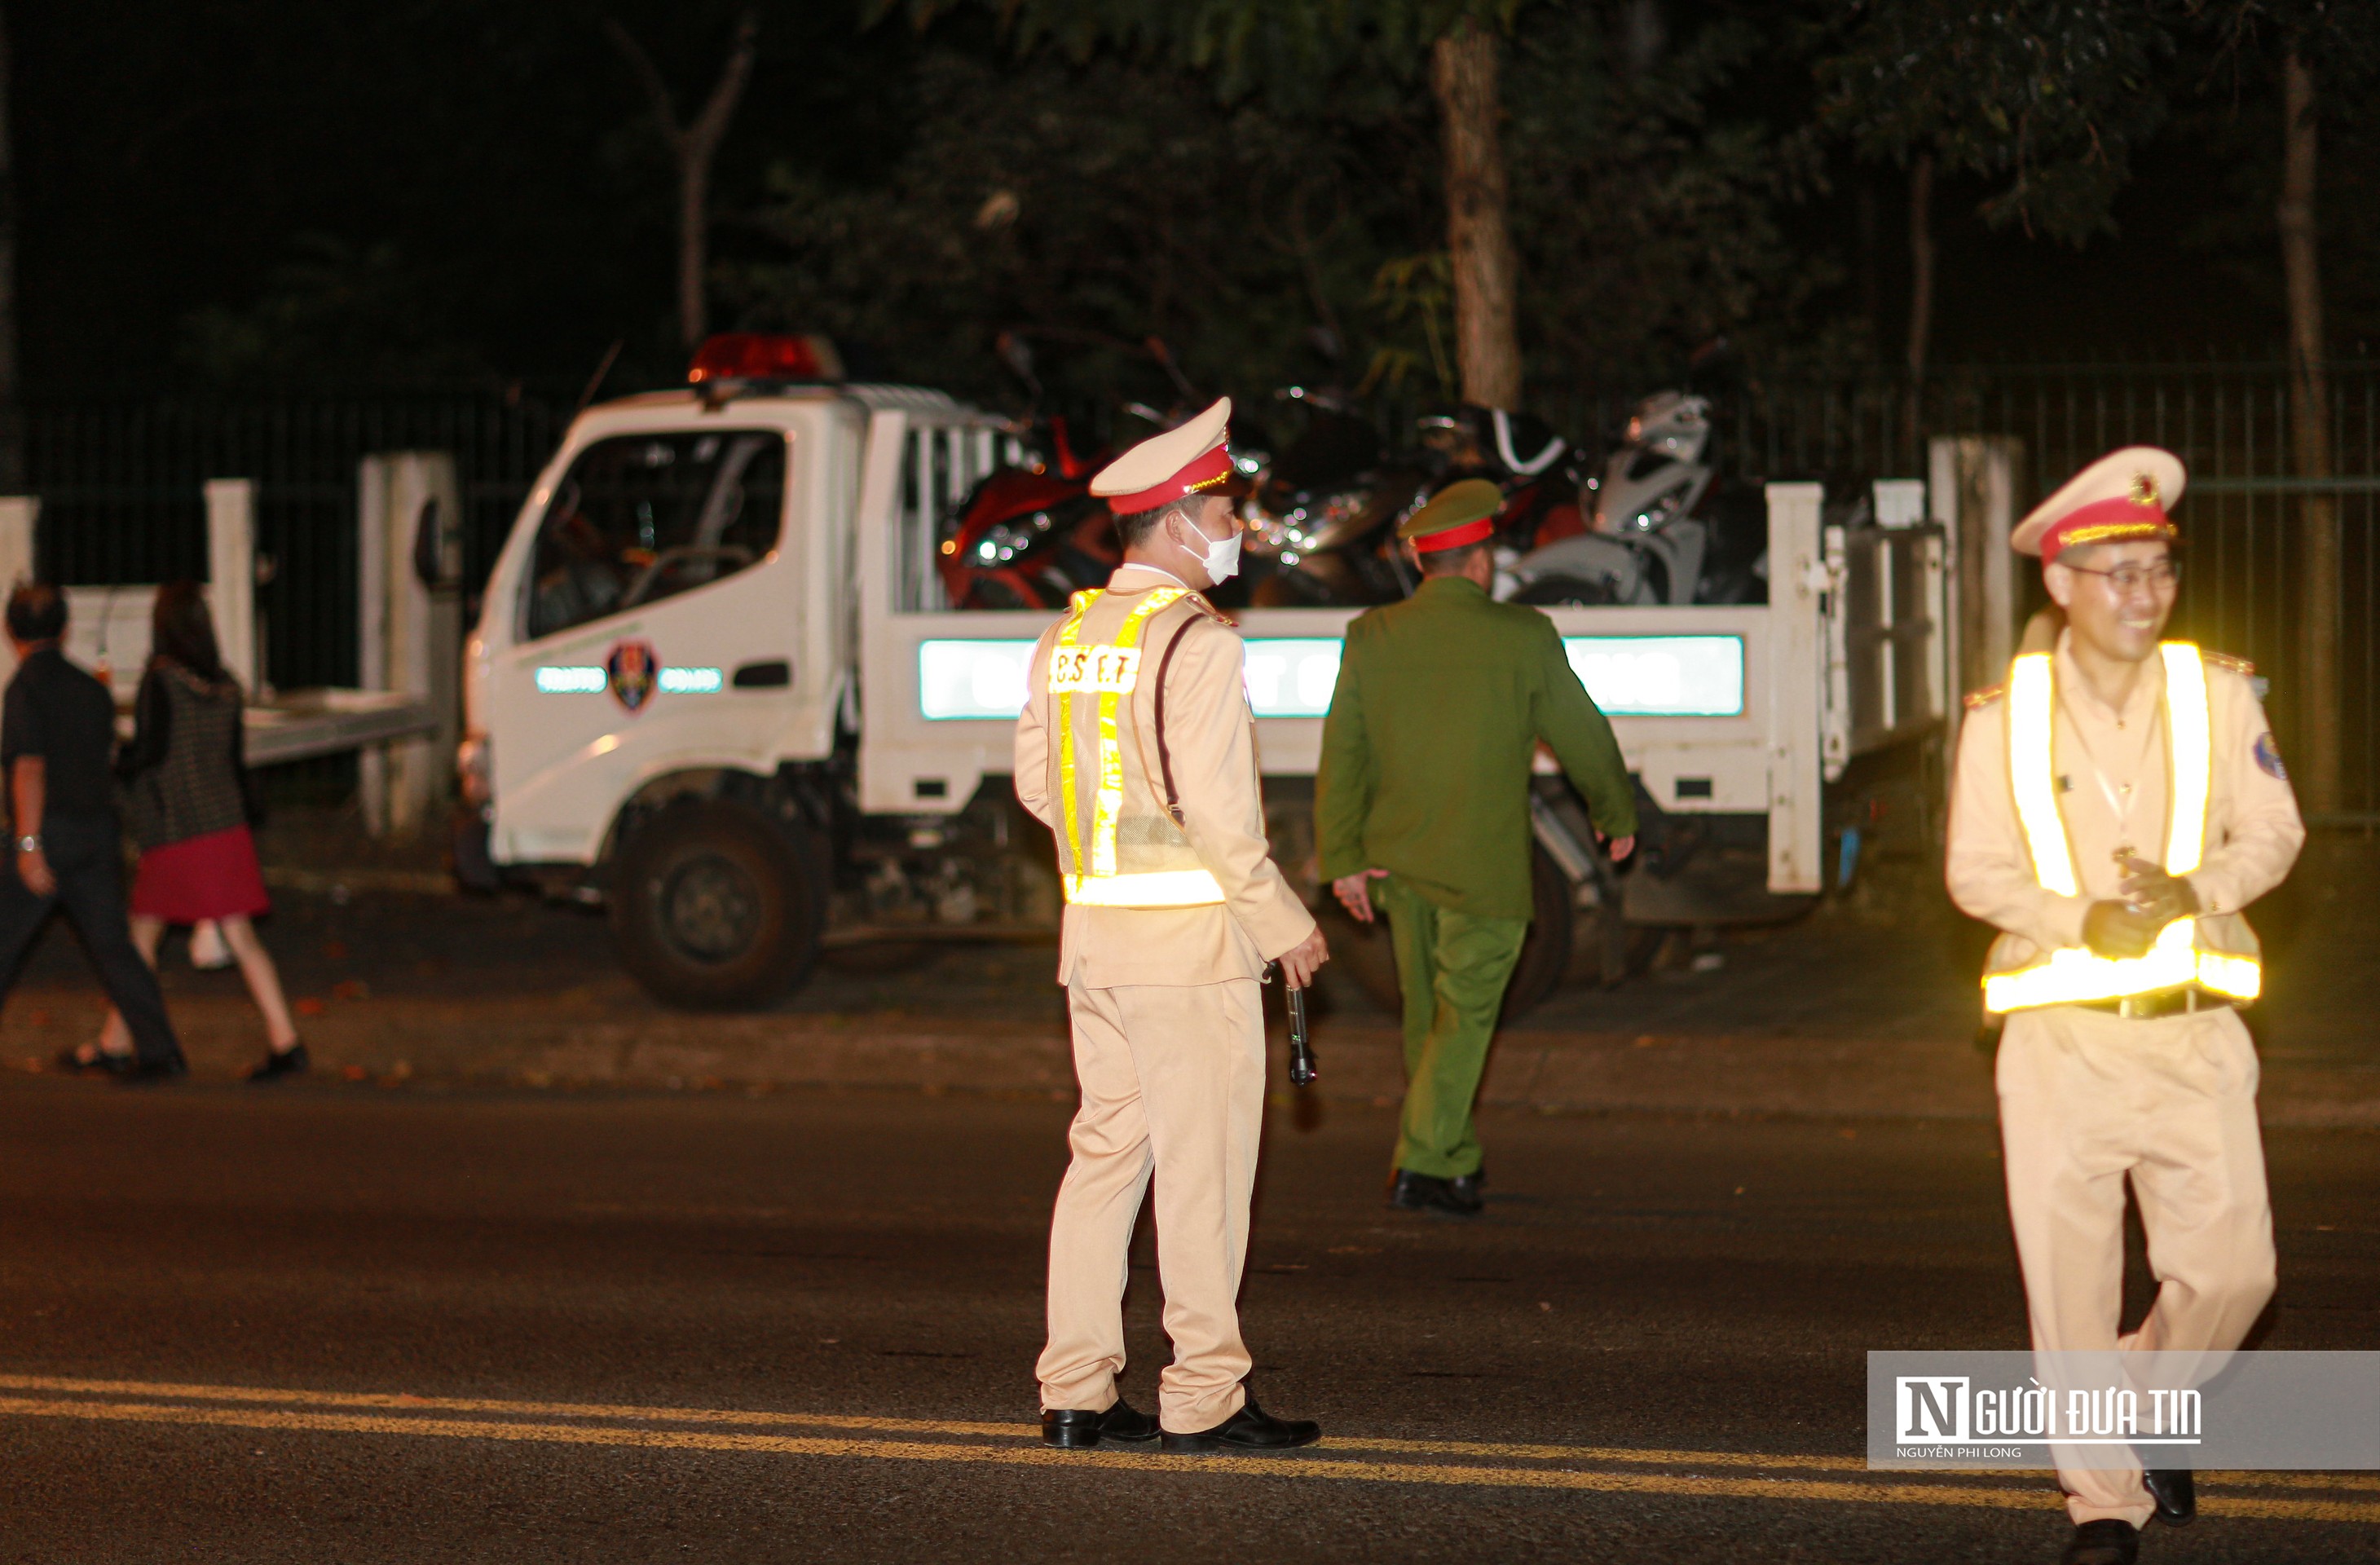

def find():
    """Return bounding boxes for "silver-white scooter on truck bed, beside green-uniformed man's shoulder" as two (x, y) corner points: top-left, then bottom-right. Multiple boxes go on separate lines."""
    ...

(1497, 392), (1713, 604)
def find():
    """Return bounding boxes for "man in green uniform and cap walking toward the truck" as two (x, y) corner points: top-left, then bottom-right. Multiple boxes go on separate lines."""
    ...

(1314, 478), (1637, 1218)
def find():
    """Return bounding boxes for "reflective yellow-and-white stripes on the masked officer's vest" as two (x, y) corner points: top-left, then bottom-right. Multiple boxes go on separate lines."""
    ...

(1050, 588), (1223, 909)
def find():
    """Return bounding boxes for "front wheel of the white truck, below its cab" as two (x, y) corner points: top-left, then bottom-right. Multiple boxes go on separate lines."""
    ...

(611, 799), (821, 1011)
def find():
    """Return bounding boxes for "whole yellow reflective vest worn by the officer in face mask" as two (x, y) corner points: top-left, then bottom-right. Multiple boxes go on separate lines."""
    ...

(1047, 588), (1223, 909)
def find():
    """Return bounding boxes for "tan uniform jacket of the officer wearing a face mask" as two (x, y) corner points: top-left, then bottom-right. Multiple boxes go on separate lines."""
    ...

(1016, 566), (1314, 990)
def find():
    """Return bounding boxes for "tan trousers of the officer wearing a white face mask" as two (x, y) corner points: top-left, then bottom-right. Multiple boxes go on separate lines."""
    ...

(1038, 977), (1264, 1435)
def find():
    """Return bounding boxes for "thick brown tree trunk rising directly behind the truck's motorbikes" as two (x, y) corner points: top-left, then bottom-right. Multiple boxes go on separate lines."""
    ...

(1430, 21), (1521, 409)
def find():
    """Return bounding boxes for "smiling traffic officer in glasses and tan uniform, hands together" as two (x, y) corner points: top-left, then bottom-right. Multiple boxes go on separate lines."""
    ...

(1947, 447), (2306, 1565)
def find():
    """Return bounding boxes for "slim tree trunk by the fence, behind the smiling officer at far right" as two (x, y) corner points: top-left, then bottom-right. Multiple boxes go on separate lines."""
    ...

(2276, 47), (2339, 811)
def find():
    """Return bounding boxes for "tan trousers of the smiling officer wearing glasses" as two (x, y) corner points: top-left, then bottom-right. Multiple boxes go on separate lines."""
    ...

(1999, 1006), (2273, 1527)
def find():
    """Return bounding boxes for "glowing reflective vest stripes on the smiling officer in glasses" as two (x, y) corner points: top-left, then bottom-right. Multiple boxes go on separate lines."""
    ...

(1982, 642), (2263, 1011)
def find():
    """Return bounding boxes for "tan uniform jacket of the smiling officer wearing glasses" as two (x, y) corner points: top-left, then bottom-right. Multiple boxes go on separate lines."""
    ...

(1947, 633), (2306, 972)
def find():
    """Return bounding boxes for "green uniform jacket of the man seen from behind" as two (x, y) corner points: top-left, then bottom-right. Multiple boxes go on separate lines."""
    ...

(1314, 575), (1637, 918)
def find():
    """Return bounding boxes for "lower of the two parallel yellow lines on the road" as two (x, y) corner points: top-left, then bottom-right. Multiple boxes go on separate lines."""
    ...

(0, 1377), (2380, 1522)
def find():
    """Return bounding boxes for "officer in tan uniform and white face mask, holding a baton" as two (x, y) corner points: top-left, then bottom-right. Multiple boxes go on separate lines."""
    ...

(1016, 399), (1328, 1451)
